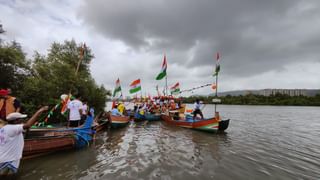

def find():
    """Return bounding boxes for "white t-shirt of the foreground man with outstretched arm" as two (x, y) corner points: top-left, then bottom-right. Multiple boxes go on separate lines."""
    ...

(0, 124), (24, 165)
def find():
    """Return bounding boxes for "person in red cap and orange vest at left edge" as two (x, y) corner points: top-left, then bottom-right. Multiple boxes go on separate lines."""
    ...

(0, 89), (20, 120)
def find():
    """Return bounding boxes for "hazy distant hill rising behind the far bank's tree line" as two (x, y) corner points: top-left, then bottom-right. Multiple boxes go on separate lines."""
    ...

(214, 89), (320, 96)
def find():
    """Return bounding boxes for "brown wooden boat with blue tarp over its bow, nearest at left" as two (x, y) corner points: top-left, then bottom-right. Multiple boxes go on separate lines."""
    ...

(23, 116), (95, 158)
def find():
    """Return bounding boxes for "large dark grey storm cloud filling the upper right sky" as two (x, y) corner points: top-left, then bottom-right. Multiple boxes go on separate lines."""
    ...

(78, 0), (320, 76)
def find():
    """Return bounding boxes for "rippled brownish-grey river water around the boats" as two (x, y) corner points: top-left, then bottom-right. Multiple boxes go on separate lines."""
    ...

(19, 105), (320, 180)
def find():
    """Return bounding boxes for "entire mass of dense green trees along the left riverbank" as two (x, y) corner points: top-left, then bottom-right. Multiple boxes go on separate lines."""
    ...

(0, 40), (110, 118)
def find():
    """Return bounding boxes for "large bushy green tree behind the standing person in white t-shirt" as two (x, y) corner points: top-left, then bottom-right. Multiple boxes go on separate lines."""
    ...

(19, 40), (110, 115)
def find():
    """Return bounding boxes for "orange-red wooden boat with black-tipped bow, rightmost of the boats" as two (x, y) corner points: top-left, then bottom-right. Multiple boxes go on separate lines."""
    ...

(161, 113), (229, 132)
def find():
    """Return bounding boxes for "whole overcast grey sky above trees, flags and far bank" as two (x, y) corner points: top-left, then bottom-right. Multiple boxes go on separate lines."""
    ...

(0, 0), (320, 95)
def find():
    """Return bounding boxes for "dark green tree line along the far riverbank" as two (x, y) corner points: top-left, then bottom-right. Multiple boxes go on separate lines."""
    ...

(182, 94), (320, 106)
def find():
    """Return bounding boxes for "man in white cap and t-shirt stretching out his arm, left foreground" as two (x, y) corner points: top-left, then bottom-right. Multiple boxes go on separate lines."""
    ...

(0, 106), (48, 177)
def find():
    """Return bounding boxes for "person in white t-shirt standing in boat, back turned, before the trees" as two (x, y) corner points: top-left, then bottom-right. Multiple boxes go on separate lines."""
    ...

(68, 94), (82, 127)
